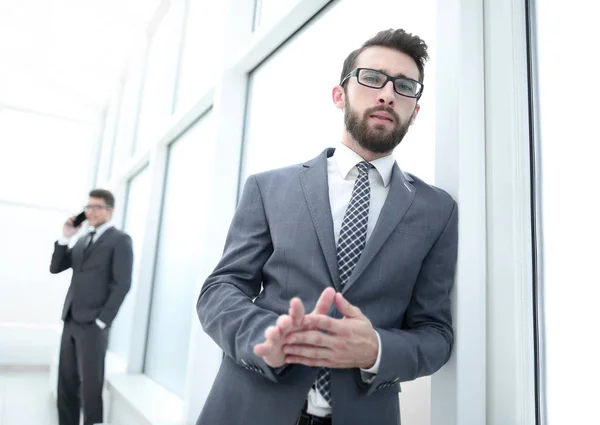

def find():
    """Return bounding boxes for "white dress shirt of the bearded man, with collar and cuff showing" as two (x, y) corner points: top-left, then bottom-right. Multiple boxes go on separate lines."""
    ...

(306, 144), (396, 417)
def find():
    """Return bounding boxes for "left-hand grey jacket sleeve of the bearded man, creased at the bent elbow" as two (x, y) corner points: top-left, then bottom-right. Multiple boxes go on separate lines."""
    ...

(196, 176), (278, 382)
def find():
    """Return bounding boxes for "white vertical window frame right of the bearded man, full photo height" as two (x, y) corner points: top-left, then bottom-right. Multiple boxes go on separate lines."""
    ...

(484, 0), (540, 425)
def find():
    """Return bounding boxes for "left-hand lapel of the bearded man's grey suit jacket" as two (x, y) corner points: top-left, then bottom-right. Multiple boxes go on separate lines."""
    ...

(300, 149), (340, 290)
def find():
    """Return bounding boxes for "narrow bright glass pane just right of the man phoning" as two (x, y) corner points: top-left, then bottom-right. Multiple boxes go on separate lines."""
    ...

(109, 167), (150, 359)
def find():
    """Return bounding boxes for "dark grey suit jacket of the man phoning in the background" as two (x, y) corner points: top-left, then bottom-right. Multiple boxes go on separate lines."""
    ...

(50, 227), (133, 326)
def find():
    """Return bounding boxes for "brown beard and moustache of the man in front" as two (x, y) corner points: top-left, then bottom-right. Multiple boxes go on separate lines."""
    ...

(344, 103), (410, 153)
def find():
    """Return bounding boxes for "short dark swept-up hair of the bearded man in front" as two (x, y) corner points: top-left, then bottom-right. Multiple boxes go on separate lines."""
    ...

(340, 28), (429, 83)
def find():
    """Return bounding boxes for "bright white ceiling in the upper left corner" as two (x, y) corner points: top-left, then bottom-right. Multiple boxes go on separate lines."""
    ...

(0, 0), (170, 121)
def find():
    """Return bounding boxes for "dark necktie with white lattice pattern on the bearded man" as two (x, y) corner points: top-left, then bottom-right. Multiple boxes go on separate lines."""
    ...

(317, 161), (373, 405)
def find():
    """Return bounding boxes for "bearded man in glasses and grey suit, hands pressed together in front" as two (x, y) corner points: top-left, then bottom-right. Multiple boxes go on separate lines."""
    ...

(197, 30), (458, 425)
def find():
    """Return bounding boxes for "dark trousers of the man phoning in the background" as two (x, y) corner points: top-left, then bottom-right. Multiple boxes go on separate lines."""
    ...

(57, 317), (108, 425)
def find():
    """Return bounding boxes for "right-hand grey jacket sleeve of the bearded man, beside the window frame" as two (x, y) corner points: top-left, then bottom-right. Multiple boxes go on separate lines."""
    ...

(357, 202), (458, 393)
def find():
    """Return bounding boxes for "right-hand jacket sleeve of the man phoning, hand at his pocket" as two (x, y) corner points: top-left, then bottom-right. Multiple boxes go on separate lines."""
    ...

(98, 234), (133, 326)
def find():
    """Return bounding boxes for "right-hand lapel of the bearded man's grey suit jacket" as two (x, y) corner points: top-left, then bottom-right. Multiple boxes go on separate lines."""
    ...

(343, 164), (416, 292)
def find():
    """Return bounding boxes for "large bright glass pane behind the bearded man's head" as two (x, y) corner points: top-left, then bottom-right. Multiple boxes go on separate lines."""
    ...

(242, 0), (437, 425)
